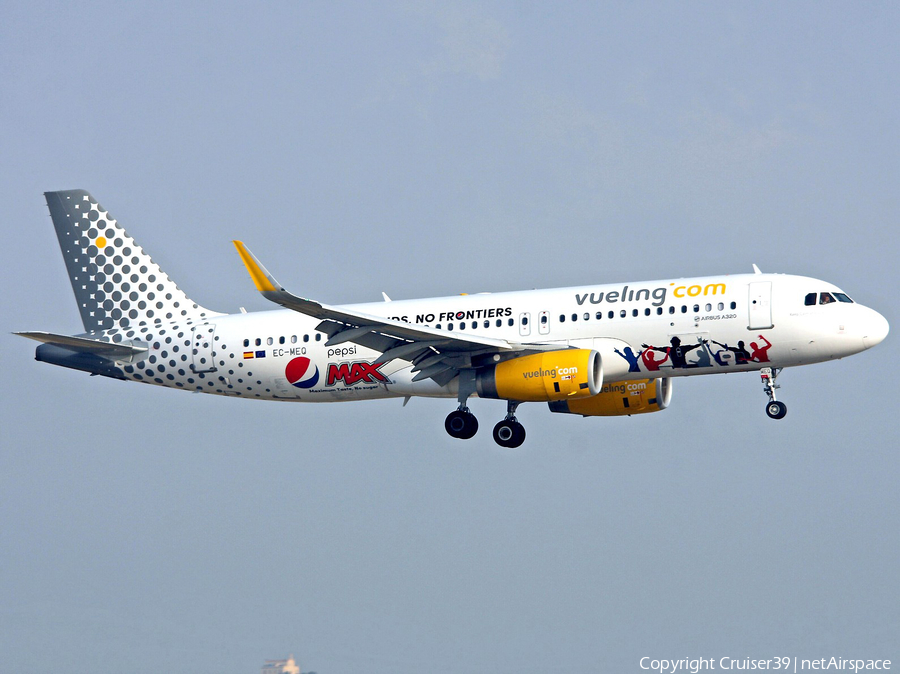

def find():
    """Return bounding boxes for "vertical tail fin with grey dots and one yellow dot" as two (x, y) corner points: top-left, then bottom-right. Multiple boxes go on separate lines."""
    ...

(44, 190), (215, 332)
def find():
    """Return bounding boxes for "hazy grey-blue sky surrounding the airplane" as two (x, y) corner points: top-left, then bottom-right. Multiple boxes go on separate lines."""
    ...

(0, 2), (900, 674)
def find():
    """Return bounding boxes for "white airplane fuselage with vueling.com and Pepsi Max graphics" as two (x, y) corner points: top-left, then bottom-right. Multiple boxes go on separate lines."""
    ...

(114, 274), (887, 402)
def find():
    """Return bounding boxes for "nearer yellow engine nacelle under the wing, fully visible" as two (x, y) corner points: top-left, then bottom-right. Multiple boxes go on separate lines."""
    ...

(477, 349), (603, 402)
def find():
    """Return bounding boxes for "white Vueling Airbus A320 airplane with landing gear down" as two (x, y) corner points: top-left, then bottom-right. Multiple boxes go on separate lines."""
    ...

(15, 190), (889, 448)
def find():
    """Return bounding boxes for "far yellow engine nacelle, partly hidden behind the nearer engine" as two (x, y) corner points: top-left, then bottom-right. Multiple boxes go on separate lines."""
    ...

(549, 377), (672, 417)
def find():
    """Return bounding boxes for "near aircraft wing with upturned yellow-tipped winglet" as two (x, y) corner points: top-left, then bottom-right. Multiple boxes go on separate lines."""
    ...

(233, 241), (548, 386)
